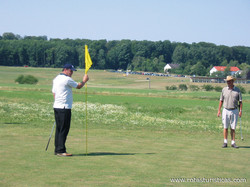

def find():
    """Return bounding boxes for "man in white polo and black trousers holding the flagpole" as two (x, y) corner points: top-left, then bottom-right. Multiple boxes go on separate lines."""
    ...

(52, 64), (89, 156)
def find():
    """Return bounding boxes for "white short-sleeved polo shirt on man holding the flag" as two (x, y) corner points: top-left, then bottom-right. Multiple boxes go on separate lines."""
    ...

(52, 73), (78, 109)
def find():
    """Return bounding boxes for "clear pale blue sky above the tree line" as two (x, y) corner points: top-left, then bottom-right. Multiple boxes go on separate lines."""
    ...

(0, 0), (250, 47)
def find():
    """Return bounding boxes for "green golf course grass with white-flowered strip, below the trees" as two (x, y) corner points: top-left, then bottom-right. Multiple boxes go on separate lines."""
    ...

(0, 66), (250, 187)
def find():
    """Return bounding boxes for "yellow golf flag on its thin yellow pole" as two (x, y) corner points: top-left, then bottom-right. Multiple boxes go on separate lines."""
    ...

(85, 45), (92, 155)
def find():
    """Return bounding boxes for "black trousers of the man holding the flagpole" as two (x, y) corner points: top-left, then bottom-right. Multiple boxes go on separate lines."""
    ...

(54, 108), (71, 153)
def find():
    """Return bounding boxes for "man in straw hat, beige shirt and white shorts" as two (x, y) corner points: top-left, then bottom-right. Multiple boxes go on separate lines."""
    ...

(217, 76), (242, 148)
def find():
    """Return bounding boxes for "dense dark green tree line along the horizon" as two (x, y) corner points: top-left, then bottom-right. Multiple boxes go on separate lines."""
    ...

(0, 33), (250, 76)
